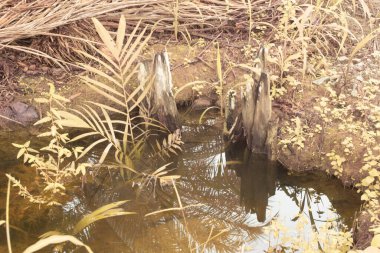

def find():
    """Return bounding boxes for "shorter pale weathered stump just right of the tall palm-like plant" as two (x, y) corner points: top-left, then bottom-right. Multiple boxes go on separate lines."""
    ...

(138, 50), (181, 132)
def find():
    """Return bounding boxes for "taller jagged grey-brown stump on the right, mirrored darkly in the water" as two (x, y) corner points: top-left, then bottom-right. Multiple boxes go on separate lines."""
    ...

(226, 47), (278, 160)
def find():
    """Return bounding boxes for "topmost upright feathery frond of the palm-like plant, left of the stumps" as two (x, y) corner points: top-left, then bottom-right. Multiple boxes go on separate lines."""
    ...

(76, 16), (151, 110)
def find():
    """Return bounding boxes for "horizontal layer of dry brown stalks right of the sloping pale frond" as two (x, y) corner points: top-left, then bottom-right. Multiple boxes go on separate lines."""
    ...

(106, 0), (281, 36)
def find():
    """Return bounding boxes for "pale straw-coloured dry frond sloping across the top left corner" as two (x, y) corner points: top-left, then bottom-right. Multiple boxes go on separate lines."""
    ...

(0, 0), (150, 44)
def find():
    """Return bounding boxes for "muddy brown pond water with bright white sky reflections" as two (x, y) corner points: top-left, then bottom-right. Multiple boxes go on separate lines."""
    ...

(0, 113), (360, 253)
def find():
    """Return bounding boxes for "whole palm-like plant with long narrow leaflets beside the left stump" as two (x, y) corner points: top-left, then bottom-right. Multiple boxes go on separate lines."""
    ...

(55, 16), (177, 176)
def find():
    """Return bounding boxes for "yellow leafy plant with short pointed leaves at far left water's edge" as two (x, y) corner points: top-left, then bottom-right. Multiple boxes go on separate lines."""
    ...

(7, 84), (89, 205)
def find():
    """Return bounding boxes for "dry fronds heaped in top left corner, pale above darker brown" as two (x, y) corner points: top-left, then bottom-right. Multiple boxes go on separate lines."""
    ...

(0, 0), (150, 64)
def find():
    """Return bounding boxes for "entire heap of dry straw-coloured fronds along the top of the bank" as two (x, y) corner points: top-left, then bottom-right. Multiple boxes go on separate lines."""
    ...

(0, 0), (281, 65)
